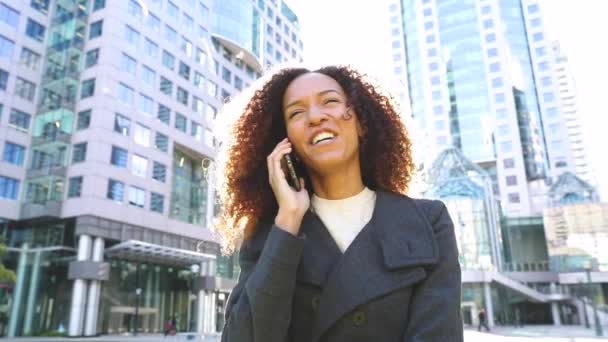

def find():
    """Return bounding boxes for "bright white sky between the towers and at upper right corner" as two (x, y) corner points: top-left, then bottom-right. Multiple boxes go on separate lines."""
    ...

(287, 0), (608, 201)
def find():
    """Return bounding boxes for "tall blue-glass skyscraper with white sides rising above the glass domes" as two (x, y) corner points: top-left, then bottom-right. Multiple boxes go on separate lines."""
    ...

(390, 0), (588, 216)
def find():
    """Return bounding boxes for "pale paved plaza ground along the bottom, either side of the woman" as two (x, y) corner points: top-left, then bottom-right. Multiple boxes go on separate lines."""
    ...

(0, 326), (608, 342)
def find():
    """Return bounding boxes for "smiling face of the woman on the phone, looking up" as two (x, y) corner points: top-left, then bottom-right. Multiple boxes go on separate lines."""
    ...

(283, 73), (361, 174)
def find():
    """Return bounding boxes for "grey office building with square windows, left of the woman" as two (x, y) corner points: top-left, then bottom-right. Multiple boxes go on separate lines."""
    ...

(0, 0), (302, 336)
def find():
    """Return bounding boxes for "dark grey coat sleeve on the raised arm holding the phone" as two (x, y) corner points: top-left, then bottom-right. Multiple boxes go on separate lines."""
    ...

(221, 226), (304, 342)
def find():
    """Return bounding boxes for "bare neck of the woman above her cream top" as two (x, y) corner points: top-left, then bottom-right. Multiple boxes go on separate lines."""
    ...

(310, 168), (365, 200)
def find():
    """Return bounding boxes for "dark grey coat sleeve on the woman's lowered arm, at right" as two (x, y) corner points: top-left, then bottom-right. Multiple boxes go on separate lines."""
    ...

(403, 201), (463, 342)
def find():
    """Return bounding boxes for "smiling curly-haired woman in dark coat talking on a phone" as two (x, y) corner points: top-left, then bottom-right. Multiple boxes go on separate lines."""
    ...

(219, 67), (463, 342)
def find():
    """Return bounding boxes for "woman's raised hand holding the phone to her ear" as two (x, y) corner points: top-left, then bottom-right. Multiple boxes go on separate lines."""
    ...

(267, 138), (310, 235)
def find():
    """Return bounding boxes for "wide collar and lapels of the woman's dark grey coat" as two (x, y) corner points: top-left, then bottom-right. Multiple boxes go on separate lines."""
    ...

(308, 191), (438, 341)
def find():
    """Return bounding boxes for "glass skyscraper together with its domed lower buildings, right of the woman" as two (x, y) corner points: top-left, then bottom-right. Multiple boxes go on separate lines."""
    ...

(394, 0), (608, 325)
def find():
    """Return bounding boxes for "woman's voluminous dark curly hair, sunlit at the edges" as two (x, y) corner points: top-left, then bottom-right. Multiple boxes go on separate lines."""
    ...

(215, 66), (414, 253)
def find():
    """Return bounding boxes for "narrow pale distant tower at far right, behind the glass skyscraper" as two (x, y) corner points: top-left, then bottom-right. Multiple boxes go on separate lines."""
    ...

(549, 41), (595, 184)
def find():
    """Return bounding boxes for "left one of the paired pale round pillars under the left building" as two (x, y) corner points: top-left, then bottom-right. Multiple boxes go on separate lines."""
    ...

(68, 235), (92, 336)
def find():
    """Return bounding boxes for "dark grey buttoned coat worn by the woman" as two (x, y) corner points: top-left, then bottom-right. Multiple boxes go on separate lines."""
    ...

(222, 191), (463, 342)
